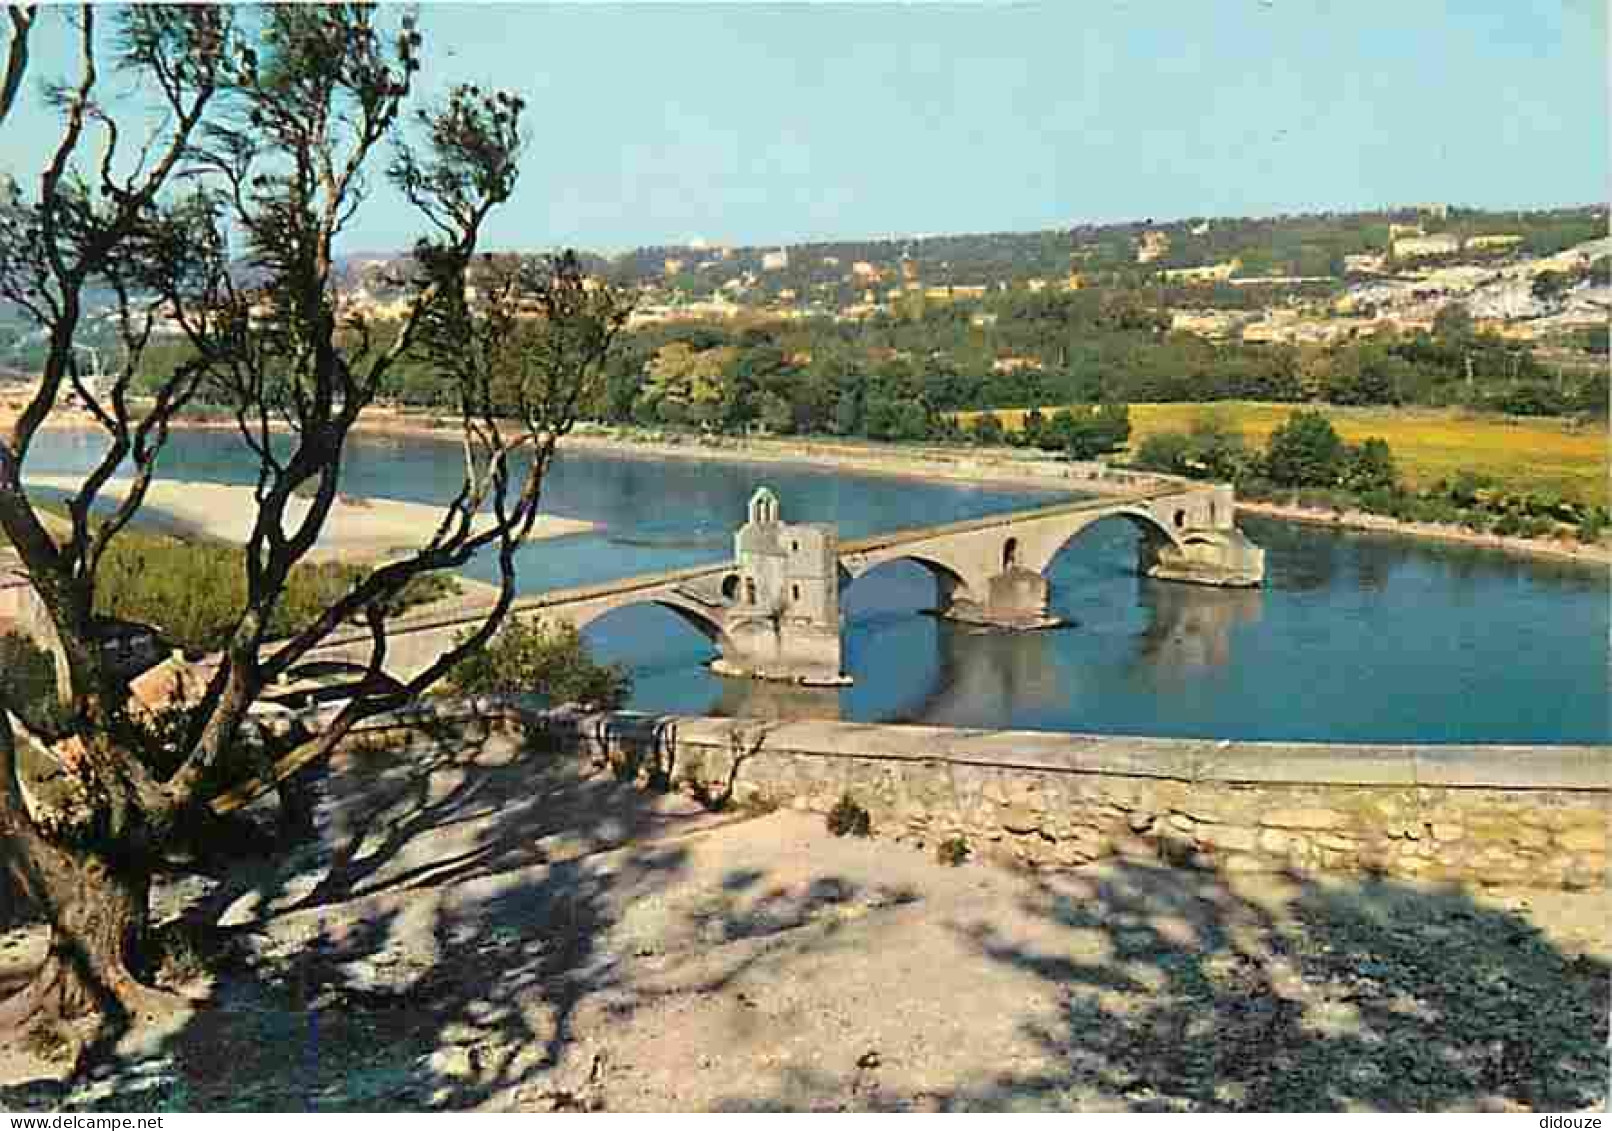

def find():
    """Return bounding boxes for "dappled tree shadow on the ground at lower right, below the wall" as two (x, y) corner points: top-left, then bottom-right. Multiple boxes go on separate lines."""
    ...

(725, 864), (1609, 1112)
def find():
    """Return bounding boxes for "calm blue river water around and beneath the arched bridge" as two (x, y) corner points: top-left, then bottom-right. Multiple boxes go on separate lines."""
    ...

(29, 432), (1612, 743)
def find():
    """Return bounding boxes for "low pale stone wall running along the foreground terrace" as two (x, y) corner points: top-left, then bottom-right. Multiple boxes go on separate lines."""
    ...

(534, 712), (1612, 889)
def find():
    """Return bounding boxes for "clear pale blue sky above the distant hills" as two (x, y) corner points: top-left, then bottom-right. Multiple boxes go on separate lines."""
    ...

(0, 0), (1609, 250)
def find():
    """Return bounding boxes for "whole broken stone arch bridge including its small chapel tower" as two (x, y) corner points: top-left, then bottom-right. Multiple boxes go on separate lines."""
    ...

(310, 485), (1265, 685)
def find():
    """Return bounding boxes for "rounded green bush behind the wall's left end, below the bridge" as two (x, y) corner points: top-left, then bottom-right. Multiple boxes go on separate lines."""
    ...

(448, 617), (632, 711)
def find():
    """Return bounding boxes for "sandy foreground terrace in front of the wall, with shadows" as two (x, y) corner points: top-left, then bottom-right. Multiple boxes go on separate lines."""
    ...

(0, 738), (1612, 1112)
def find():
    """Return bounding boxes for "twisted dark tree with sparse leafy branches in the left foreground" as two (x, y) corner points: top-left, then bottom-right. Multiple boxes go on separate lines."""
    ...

(0, 5), (625, 1028)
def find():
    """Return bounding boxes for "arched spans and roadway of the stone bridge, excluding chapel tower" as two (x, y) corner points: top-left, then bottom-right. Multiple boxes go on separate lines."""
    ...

(296, 485), (1264, 678)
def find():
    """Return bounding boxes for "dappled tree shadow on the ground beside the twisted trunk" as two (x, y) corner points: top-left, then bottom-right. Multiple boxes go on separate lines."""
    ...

(0, 721), (735, 1110)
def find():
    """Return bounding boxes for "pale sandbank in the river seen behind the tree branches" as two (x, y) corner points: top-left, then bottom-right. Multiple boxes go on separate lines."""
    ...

(26, 475), (595, 559)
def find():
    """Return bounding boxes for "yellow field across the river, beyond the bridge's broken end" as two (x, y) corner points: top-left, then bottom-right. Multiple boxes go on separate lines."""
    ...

(958, 401), (1609, 504)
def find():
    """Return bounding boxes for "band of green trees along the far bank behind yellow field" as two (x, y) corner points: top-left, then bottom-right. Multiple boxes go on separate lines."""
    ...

(320, 292), (1607, 440)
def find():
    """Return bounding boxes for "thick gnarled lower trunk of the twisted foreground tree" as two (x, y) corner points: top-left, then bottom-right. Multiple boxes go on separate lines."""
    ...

(0, 830), (174, 1033)
